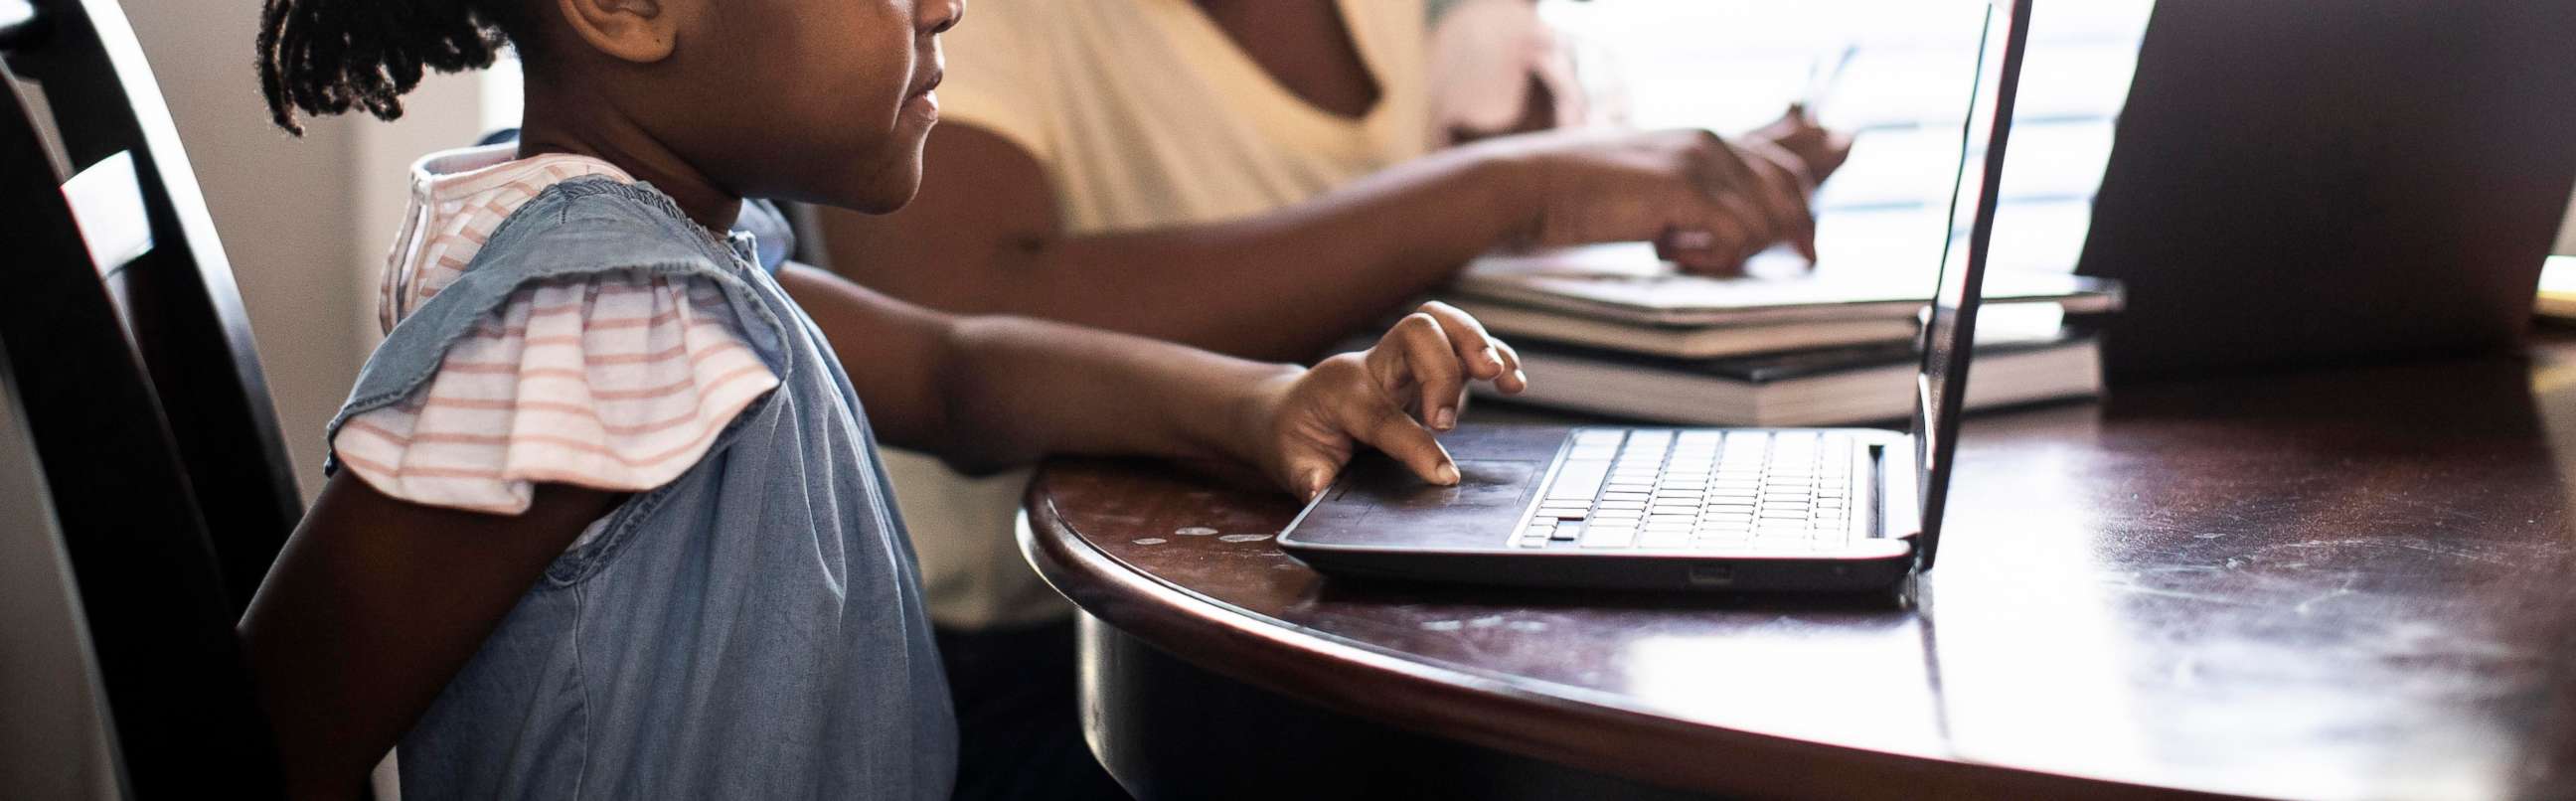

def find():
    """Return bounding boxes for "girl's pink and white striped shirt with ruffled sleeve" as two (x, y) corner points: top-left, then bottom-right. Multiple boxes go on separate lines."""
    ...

(332, 147), (778, 517)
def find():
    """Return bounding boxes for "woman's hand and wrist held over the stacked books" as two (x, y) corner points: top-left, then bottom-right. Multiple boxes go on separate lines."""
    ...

(1471, 113), (1850, 275)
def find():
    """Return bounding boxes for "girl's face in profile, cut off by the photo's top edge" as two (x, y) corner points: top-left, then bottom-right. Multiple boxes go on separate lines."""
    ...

(654, 0), (966, 212)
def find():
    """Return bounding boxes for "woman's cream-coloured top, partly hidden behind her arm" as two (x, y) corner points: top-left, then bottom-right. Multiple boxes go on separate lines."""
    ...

(886, 0), (1432, 628)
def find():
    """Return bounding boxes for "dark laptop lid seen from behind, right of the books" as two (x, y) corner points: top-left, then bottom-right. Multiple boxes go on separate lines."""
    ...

(2076, 0), (2576, 382)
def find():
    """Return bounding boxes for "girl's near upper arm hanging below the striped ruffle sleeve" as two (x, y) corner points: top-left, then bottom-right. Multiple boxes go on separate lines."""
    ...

(240, 471), (623, 798)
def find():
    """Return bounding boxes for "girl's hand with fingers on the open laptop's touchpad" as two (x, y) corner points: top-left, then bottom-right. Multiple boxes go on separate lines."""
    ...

(1249, 301), (1530, 500)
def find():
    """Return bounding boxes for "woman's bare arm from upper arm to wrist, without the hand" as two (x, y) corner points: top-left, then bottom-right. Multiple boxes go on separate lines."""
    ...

(822, 126), (1518, 358)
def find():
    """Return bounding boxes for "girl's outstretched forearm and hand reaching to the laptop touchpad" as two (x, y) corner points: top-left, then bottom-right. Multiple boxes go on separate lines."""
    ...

(778, 265), (1525, 495)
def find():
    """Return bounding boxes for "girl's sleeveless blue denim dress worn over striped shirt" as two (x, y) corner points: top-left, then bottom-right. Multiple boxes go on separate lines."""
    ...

(325, 178), (956, 801)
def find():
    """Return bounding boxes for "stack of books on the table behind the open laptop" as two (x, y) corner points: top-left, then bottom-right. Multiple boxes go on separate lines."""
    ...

(1440, 244), (2123, 425)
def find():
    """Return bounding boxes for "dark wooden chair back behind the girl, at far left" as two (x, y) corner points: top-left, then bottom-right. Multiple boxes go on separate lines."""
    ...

(0, 0), (301, 798)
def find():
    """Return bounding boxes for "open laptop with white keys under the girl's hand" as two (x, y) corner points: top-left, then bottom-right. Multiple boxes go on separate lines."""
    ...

(1278, 0), (2029, 592)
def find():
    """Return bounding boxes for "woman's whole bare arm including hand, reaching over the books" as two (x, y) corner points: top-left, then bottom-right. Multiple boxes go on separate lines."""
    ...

(822, 126), (1814, 358)
